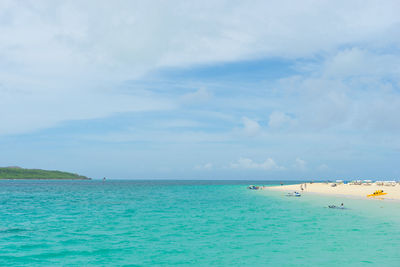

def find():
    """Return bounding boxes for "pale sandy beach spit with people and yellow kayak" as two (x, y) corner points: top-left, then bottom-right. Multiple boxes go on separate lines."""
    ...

(264, 183), (400, 200)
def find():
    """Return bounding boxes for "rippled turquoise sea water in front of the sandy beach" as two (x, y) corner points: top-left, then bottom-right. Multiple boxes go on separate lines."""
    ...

(0, 181), (400, 266)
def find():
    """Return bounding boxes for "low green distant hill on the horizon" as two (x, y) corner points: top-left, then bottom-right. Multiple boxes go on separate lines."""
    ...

(0, 166), (90, 180)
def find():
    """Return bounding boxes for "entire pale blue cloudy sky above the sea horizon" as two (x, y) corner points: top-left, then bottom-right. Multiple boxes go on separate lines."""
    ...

(0, 0), (400, 180)
